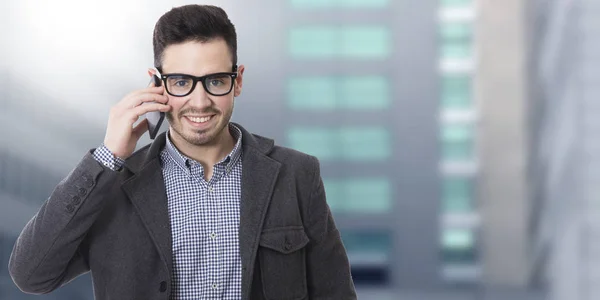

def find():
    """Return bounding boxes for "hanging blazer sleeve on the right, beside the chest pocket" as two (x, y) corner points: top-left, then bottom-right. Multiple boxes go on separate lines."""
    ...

(306, 157), (356, 300)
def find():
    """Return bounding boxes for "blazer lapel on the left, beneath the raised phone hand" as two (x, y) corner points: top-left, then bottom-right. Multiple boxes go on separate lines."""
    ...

(121, 133), (173, 272)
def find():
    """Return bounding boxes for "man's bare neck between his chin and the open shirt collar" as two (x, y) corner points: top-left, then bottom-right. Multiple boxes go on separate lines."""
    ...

(169, 126), (235, 171)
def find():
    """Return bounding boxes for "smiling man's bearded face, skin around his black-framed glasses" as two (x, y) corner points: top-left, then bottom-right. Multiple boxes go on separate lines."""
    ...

(162, 39), (244, 146)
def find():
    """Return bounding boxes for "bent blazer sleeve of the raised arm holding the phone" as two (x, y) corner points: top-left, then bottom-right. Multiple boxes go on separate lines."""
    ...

(8, 151), (119, 294)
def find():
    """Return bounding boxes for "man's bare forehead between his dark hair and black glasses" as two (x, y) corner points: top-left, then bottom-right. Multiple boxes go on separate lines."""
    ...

(162, 39), (233, 76)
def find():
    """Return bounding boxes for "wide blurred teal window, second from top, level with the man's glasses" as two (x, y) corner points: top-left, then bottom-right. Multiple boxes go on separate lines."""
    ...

(288, 76), (390, 112)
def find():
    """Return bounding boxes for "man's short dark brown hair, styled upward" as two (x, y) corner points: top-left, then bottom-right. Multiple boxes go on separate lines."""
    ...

(152, 4), (237, 69)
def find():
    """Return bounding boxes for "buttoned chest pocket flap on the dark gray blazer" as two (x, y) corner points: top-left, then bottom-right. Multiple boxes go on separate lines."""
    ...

(260, 227), (309, 254)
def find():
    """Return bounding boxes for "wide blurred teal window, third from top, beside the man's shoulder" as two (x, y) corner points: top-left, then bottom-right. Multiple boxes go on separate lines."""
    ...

(288, 126), (392, 161)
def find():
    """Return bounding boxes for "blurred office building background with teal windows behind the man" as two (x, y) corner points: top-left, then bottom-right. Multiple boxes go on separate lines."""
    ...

(0, 0), (600, 300)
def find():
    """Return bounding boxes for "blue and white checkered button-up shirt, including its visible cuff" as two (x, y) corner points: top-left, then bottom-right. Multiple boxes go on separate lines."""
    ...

(94, 124), (242, 300)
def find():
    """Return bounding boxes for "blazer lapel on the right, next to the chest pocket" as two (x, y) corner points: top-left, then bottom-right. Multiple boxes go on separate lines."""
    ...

(235, 124), (281, 299)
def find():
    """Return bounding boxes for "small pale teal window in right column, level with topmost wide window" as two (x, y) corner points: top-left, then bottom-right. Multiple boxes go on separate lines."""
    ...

(440, 22), (473, 59)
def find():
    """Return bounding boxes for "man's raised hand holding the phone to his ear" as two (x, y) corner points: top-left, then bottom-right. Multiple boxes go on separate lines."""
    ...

(104, 83), (171, 159)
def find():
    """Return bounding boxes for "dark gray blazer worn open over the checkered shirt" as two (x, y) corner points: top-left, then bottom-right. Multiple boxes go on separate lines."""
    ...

(9, 124), (356, 300)
